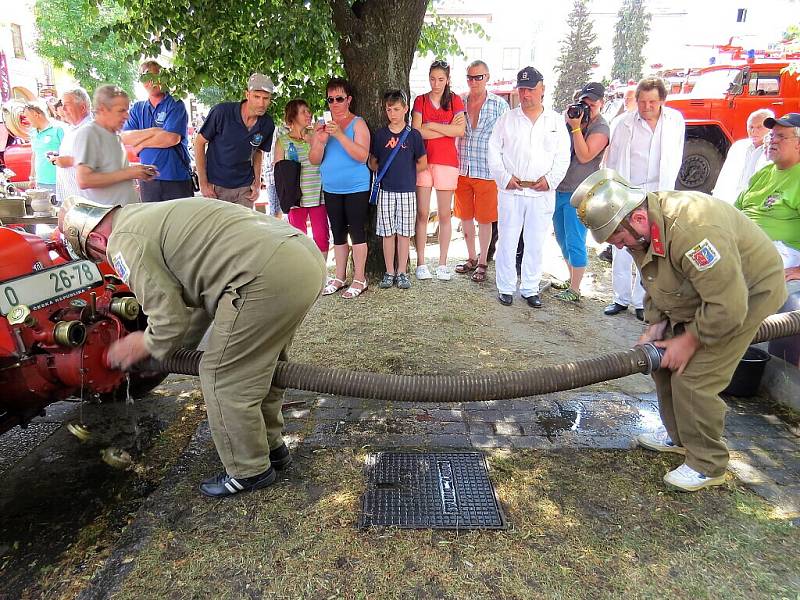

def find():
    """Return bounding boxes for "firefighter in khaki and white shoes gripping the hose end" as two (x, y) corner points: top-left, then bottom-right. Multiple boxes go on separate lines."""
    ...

(571, 169), (786, 491)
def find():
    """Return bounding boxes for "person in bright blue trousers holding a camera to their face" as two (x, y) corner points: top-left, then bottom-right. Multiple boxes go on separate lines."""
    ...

(553, 82), (609, 302)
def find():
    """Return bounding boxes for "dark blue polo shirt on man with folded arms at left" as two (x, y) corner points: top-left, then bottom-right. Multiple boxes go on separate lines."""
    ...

(122, 94), (192, 181)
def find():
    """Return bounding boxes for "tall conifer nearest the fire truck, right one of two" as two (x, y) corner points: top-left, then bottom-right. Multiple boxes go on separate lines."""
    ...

(611, 0), (652, 81)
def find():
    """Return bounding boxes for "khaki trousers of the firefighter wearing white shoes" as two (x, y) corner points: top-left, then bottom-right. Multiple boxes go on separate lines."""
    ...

(653, 311), (772, 477)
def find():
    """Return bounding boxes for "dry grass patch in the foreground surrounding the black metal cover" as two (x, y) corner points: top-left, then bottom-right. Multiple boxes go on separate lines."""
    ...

(106, 450), (800, 600)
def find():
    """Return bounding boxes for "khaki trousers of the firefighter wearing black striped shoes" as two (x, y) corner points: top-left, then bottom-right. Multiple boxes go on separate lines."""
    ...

(200, 234), (326, 478)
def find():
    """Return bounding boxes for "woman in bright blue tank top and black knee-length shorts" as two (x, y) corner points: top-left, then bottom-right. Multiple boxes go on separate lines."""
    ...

(309, 77), (370, 298)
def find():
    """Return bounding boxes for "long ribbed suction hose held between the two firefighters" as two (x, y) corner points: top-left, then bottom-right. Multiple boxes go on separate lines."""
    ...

(137, 310), (800, 402)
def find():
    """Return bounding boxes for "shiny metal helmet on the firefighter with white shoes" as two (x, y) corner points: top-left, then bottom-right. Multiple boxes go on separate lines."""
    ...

(570, 169), (647, 244)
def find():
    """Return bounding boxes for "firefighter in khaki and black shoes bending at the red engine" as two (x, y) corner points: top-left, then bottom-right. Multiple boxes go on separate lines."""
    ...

(59, 197), (325, 497)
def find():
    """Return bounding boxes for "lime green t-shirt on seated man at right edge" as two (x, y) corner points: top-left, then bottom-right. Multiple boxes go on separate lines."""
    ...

(736, 164), (800, 250)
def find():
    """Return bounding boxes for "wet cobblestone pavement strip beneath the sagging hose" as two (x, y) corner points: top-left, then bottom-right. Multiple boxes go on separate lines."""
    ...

(284, 390), (800, 518)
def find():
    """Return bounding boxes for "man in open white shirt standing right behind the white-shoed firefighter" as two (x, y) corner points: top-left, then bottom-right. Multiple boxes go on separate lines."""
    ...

(603, 78), (686, 321)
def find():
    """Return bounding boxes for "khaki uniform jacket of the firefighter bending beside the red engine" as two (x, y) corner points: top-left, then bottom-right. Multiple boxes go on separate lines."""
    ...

(106, 197), (300, 359)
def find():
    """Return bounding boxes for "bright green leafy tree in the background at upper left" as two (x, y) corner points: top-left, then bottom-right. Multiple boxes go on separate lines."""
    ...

(34, 0), (138, 94)
